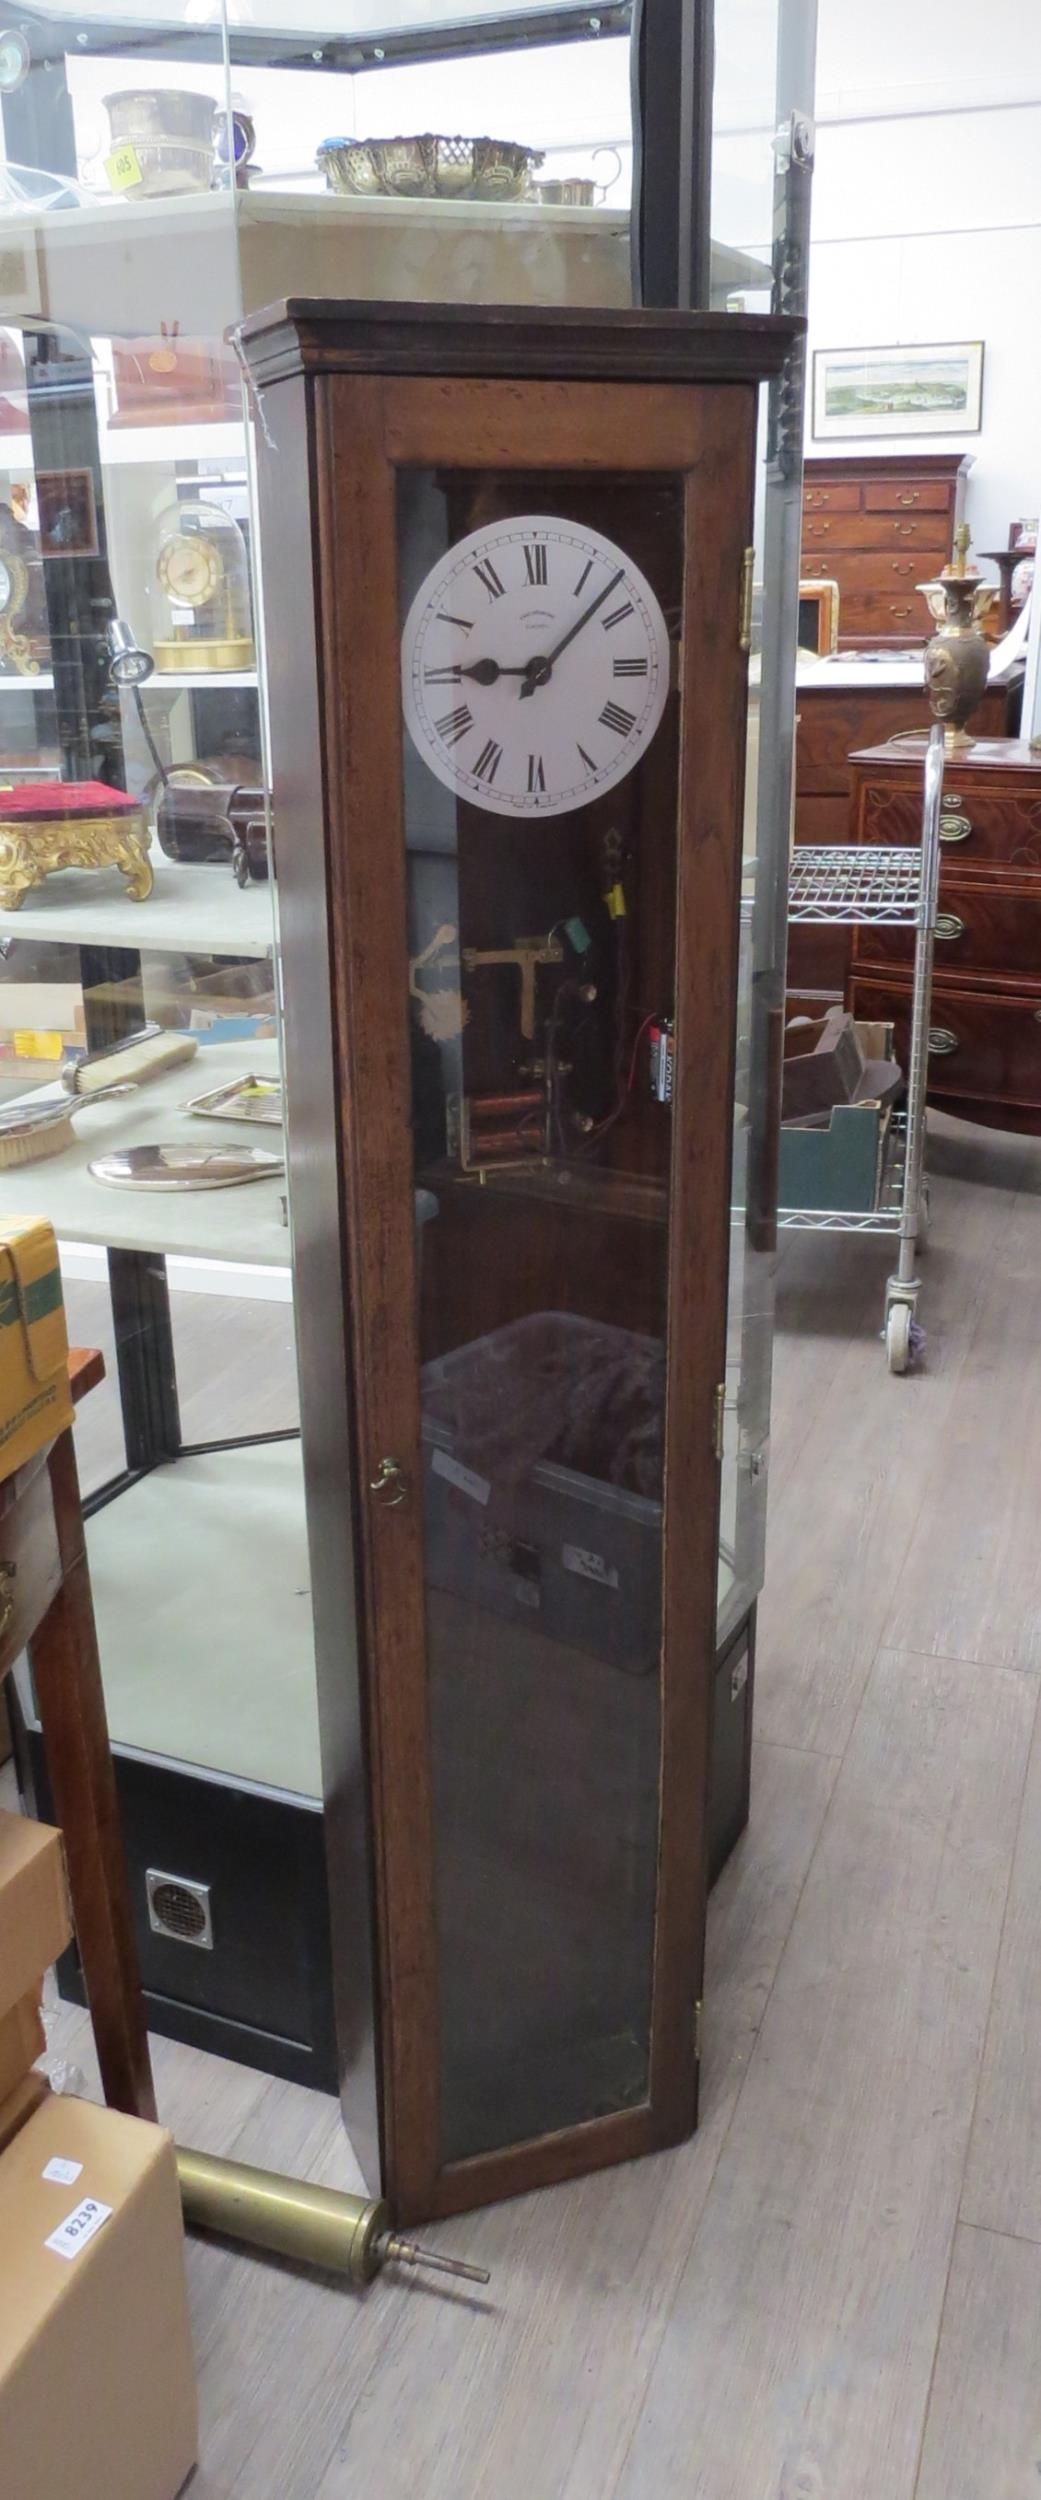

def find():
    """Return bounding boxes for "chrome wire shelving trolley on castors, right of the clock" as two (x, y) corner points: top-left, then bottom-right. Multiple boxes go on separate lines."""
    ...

(778, 720), (943, 1373)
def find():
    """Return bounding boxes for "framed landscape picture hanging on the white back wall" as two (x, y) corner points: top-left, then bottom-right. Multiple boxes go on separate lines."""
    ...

(813, 338), (983, 443)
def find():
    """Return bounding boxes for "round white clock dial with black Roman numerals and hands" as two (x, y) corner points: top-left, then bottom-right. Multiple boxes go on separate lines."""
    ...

(400, 513), (668, 818)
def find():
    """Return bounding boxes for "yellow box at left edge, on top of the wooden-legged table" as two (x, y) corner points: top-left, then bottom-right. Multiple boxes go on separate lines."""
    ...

(0, 1220), (73, 1478)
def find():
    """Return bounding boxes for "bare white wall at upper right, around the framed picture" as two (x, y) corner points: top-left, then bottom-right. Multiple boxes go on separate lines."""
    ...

(808, 0), (1041, 548)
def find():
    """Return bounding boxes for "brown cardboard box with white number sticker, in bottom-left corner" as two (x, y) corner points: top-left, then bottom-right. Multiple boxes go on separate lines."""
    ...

(0, 2093), (198, 2500)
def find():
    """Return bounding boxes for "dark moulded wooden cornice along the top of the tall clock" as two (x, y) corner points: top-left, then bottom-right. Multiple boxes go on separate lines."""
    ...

(235, 295), (806, 385)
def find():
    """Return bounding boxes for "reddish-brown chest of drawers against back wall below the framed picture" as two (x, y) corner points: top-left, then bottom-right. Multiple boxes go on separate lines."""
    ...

(801, 450), (971, 650)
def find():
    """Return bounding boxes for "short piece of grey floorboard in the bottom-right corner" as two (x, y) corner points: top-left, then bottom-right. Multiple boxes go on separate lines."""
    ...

(916, 2225), (1041, 2500)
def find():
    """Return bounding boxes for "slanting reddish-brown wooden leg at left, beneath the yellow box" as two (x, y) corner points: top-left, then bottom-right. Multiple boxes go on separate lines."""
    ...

(30, 1433), (155, 2118)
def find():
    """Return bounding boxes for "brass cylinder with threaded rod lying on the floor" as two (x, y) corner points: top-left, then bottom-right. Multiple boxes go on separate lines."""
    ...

(178, 2148), (490, 2283)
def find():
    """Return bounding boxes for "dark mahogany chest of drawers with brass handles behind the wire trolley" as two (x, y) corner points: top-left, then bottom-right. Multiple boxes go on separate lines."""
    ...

(848, 738), (1041, 1135)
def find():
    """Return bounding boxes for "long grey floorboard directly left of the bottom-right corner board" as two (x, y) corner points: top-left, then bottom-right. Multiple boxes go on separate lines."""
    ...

(613, 1653), (1033, 2500)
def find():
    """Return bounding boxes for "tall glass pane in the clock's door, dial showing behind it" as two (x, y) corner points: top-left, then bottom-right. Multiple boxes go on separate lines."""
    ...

(398, 473), (681, 2160)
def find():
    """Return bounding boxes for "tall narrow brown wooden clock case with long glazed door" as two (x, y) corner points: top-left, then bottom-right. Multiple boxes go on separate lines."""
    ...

(243, 303), (796, 2220)
